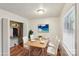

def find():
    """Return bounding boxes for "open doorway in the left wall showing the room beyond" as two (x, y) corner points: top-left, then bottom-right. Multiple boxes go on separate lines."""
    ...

(10, 21), (23, 48)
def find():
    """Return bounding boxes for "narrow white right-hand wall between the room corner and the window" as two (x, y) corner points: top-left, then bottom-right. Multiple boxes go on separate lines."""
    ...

(60, 3), (74, 55)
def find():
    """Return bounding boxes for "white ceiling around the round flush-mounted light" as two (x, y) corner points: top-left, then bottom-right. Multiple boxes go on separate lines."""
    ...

(0, 3), (64, 19)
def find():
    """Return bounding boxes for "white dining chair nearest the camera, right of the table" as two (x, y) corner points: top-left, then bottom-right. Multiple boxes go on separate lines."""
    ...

(47, 38), (60, 56)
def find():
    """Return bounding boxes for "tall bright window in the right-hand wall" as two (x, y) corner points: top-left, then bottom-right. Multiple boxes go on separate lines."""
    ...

(63, 6), (75, 55)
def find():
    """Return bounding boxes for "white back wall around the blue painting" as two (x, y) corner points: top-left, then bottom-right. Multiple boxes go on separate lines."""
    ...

(30, 17), (60, 41)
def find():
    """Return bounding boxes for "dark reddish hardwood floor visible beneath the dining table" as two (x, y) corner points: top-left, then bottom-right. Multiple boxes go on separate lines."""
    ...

(30, 47), (47, 56)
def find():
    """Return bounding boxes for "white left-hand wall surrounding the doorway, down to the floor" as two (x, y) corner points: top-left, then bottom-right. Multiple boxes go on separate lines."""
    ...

(0, 9), (28, 55)
